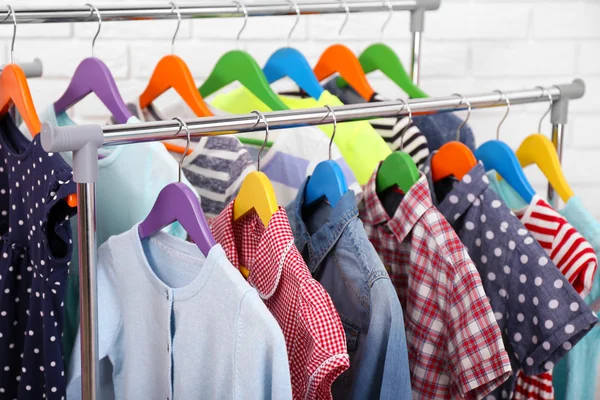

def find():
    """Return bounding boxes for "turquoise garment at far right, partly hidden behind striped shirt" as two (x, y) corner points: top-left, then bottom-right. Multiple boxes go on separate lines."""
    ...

(552, 196), (600, 400)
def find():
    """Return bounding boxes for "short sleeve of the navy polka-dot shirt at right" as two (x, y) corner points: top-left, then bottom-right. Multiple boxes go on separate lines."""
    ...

(505, 242), (597, 375)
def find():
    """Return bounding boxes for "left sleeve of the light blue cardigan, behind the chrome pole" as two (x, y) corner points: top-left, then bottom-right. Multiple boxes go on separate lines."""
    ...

(67, 246), (122, 400)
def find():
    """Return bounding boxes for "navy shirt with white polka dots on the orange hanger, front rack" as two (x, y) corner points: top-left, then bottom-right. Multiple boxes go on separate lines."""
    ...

(428, 164), (597, 399)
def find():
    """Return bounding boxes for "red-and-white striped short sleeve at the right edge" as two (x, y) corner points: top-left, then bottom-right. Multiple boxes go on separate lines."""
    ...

(551, 217), (598, 298)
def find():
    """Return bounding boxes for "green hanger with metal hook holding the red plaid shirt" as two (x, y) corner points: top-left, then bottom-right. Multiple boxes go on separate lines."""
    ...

(376, 100), (420, 194)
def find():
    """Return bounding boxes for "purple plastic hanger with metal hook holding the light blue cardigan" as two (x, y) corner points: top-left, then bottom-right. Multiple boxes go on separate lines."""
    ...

(138, 117), (216, 256)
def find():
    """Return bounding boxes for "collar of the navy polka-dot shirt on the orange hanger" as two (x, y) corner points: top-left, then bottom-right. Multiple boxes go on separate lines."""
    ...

(427, 156), (490, 223)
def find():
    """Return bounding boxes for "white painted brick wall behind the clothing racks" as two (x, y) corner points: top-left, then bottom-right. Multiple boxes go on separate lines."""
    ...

(0, 0), (600, 217)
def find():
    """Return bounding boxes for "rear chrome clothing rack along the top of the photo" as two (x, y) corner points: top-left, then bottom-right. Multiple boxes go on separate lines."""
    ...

(0, 0), (441, 84)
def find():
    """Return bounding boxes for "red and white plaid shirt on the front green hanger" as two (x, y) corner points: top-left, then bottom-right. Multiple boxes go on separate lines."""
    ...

(360, 171), (511, 399)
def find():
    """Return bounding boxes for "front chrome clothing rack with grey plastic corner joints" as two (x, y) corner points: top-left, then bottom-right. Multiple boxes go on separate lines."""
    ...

(41, 79), (585, 400)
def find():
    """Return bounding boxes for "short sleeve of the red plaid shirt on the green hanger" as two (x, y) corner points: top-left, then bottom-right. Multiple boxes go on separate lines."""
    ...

(446, 260), (511, 399)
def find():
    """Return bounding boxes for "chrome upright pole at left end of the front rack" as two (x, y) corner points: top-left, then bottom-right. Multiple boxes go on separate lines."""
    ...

(77, 182), (98, 400)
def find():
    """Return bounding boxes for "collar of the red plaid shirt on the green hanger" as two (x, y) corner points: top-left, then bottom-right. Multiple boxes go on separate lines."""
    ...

(364, 164), (433, 242)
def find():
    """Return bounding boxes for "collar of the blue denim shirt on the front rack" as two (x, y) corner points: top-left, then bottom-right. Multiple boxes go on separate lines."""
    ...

(287, 178), (358, 274)
